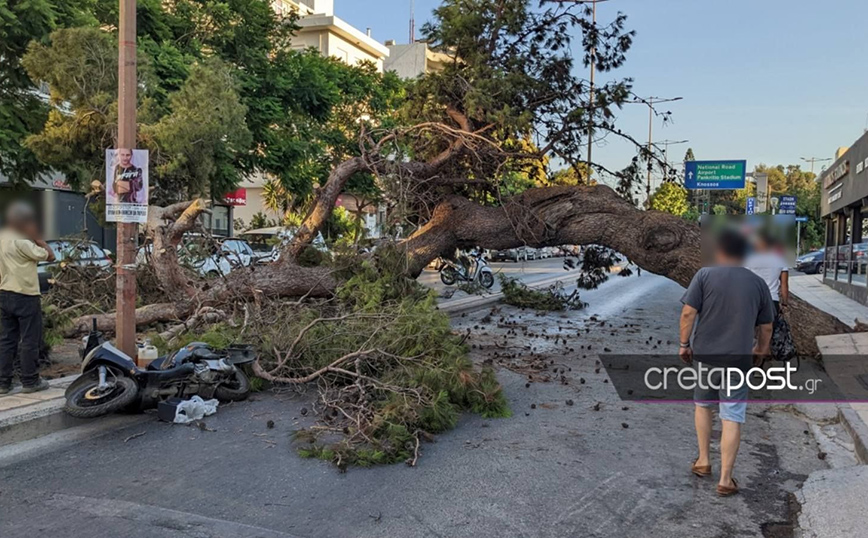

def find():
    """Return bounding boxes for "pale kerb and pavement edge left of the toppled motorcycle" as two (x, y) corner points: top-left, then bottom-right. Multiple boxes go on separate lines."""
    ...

(0, 374), (81, 447)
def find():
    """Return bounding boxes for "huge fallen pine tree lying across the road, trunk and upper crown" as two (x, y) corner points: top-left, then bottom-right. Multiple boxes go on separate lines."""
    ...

(62, 0), (847, 353)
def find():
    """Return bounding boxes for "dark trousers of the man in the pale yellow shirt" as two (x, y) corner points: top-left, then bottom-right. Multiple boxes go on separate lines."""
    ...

(0, 291), (42, 386)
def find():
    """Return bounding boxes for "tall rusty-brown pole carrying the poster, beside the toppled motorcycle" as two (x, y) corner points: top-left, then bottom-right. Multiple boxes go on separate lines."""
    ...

(115, 0), (138, 358)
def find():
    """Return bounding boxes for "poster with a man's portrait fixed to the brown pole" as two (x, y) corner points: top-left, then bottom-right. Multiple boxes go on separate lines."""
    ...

(105, 149), (148, 224)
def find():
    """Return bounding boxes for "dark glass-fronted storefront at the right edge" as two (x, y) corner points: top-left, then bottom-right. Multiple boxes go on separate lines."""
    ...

(820, 133), (868, 304)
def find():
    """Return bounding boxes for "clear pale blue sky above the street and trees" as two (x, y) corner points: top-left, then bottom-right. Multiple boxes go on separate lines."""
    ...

(335, 0), (868, 180)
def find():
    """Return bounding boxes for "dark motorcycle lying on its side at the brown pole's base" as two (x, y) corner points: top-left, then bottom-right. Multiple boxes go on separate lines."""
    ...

(64, 320), (256, 418)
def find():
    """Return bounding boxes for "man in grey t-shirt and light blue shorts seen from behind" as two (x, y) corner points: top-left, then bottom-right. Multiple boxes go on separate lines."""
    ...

(679, 231), (774, 497)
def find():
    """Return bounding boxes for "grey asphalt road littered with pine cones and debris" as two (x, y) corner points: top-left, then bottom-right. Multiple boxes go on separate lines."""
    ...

(0, 272), (826, 538)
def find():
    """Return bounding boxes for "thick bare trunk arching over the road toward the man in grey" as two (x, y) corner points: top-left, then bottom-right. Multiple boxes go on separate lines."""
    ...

(403, 182), (850, 355)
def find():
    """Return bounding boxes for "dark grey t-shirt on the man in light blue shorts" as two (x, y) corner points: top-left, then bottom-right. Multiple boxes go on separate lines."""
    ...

(681, 267), (775, 367)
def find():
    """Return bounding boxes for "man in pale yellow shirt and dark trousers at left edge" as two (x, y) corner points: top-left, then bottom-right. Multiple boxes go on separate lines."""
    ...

(0, 202), (55, 394)
